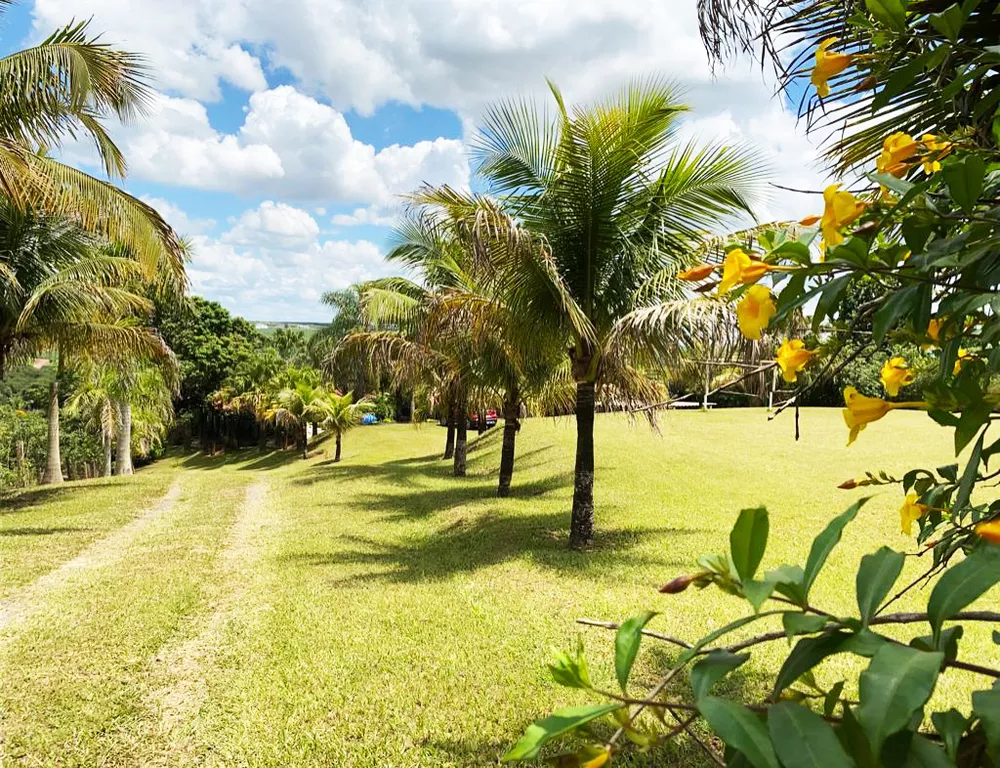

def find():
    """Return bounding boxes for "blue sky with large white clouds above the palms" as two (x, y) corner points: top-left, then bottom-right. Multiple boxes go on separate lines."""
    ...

(0, 0), (823, 322)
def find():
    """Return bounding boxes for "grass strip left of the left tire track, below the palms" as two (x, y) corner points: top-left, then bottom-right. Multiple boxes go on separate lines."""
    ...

(0, 465), (175, 599)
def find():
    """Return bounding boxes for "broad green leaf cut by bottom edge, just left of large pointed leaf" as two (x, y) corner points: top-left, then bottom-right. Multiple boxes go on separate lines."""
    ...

(767, 701), (854, 768)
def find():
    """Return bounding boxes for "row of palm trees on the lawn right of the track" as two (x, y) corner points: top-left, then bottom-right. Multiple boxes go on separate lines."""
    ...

(330, 79), (766, 548)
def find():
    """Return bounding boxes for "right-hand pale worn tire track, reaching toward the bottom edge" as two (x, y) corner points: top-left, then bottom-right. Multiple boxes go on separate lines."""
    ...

(150, 481), (278, 765)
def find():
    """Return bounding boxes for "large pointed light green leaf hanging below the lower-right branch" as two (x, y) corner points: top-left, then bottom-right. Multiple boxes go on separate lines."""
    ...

(858, 643), (944, 754)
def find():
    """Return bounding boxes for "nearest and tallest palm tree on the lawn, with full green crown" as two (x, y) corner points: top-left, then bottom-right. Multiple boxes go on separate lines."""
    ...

(473, 80), (762, 548)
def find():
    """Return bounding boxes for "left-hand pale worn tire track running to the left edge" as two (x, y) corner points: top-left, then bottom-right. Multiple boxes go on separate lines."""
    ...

(0, 478), (181, 641)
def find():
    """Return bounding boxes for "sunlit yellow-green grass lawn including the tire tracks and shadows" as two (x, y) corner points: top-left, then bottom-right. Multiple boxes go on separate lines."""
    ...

(0, 410), (1000, 768)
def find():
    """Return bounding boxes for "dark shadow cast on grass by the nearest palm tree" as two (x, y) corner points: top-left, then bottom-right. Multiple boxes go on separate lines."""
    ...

(280, 512), (699, 587)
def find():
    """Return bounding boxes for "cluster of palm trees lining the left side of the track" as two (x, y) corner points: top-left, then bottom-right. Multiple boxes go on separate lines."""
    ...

(0, 0), (186, 482)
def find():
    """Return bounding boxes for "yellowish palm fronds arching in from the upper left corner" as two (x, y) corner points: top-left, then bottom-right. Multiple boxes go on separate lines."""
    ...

(0, 0), (185, 283)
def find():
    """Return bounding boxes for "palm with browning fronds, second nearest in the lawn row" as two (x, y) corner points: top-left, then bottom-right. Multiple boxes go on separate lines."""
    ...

(387, 187), (565, 497)
